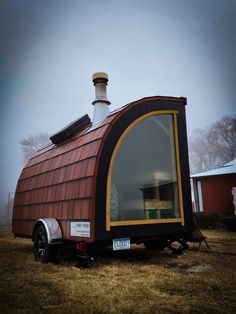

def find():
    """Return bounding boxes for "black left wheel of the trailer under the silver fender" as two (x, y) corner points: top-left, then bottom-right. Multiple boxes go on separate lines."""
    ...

(33, 225), (57, 264)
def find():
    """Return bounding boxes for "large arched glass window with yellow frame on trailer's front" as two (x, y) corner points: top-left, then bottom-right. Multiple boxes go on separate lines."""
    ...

(107, 113), (182, 230)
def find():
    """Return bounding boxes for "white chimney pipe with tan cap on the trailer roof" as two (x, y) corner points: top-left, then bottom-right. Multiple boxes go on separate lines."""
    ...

(92, 72), (110, 128)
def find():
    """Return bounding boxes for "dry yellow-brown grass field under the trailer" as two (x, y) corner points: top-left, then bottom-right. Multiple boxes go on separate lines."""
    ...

(0, 230), (236, 314)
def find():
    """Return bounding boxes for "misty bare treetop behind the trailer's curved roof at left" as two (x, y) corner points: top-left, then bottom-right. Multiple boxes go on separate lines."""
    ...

(20, 133), (50, 162)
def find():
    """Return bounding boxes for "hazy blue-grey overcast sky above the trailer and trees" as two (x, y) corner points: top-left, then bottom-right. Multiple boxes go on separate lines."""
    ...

(0, 0), (236, 201)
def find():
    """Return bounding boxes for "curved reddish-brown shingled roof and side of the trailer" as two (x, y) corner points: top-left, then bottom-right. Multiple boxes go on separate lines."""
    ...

(13, 96), (186, 233)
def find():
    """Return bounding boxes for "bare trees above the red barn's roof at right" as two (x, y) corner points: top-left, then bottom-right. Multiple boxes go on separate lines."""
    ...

(189, 116), (236, 173)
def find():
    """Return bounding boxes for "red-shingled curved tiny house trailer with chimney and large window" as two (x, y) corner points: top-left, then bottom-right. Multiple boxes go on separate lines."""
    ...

(12, 72), (192, 262)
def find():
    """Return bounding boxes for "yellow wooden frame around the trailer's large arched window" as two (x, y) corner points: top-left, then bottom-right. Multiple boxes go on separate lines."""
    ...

(106, 110), (184, 231)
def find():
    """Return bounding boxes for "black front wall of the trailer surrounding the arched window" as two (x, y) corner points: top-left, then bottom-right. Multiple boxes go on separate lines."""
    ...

(95, 97), (192, 240)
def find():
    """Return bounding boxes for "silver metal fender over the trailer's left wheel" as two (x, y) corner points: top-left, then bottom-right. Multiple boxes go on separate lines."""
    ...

(33, 218), (62, 244)
